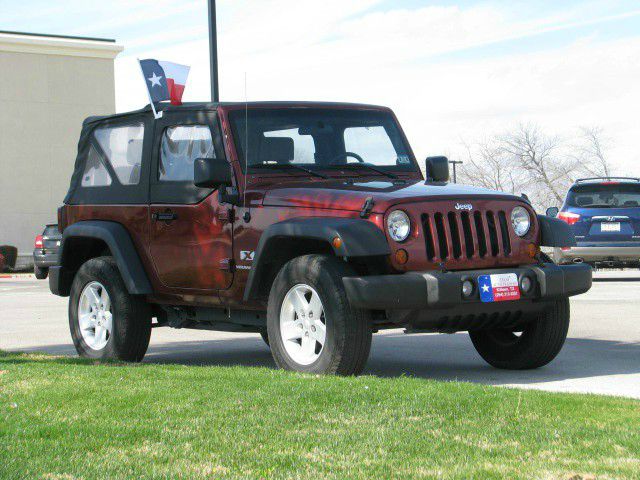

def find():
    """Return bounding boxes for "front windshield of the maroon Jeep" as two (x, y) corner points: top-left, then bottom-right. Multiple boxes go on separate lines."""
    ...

(229, 108), (417, 172)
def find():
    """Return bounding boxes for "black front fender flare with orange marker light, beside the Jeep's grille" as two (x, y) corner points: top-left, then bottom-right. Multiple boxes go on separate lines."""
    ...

(244, 217), (391, 301)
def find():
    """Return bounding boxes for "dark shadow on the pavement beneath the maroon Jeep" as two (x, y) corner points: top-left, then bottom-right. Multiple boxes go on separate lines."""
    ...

(11, 331), (640, 392)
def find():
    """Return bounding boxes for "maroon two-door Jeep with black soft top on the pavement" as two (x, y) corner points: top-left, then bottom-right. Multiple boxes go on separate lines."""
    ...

(50, 103), (591, 375)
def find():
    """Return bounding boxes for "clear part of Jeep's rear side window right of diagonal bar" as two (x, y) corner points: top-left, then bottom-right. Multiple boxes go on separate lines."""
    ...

(93, 123), (144, 185)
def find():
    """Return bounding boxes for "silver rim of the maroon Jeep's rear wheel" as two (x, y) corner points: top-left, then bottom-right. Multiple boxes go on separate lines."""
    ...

(78, 282), (113, 350)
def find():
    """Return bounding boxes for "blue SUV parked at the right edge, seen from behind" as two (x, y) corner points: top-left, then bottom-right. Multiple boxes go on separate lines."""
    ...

(547, 177), (640, 268)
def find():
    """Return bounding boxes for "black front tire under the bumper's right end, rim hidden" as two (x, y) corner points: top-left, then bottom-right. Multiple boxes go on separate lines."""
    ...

(469, 298), (570, 370)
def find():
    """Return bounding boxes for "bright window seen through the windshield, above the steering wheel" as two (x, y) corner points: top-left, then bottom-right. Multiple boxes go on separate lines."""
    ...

(344, 126), (398, 165)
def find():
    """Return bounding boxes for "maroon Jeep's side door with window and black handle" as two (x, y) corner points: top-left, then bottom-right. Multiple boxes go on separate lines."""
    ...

(149, 111), (233, 293)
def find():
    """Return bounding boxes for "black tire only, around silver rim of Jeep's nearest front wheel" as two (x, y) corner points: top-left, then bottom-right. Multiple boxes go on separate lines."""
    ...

(267, 255), (372, 375)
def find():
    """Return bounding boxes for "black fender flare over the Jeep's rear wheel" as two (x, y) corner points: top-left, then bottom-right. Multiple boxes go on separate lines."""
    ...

(59, 220), (153, 295)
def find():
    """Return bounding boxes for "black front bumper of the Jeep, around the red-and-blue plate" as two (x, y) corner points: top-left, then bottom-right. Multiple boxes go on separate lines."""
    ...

(343, 263), (591, 315)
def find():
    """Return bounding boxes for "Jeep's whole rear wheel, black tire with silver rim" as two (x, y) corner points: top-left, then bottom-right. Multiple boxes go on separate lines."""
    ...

(69, 257), (151, 362)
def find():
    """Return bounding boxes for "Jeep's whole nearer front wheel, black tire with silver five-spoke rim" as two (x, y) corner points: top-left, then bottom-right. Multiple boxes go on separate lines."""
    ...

(267, 255), (372, 375)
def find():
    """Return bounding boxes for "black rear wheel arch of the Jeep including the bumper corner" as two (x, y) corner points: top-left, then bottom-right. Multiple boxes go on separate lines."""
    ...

(49, 220), (153, 296)
